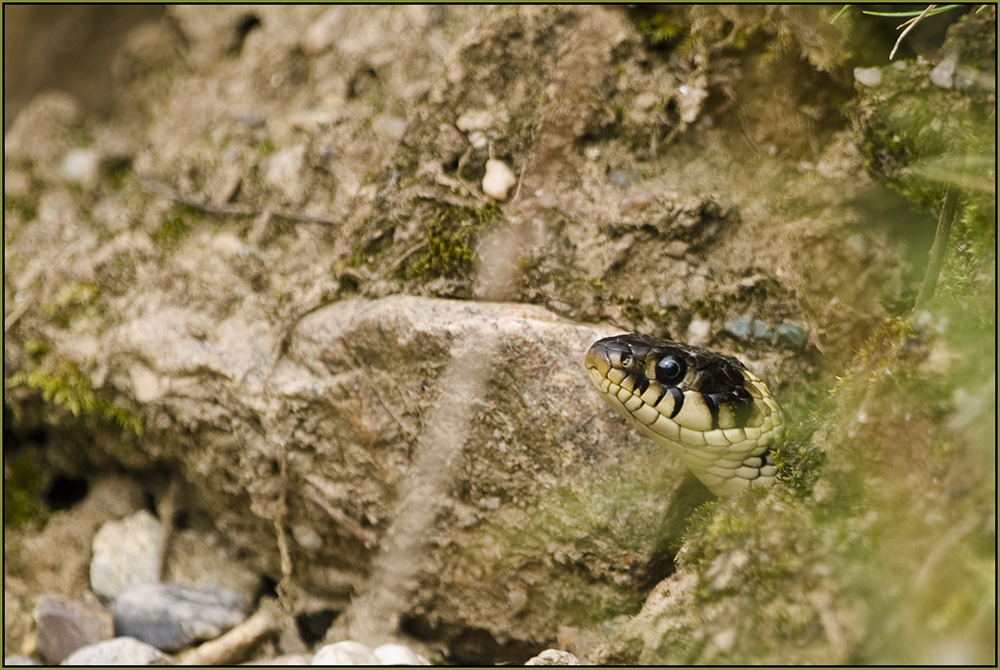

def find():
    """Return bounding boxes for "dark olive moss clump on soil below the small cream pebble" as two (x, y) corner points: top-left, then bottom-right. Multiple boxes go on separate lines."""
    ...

(403, 203), (500, 279)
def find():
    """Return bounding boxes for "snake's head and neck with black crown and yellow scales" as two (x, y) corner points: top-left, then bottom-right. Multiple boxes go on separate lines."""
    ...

(586, 333), (784, 496)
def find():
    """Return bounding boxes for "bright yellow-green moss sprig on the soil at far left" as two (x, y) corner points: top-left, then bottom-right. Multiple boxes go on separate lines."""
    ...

(7, 357), (143, 435)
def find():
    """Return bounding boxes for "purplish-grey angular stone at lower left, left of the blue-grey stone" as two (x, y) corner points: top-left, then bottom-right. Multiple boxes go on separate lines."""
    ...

(34, 596), (115, 664)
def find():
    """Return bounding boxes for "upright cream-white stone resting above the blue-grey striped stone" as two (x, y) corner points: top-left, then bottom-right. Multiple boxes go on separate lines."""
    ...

(90, 510), (161, 600)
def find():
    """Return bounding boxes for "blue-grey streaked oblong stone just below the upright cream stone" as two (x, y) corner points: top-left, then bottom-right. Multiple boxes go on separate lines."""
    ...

(111, 584), (250, 651)
